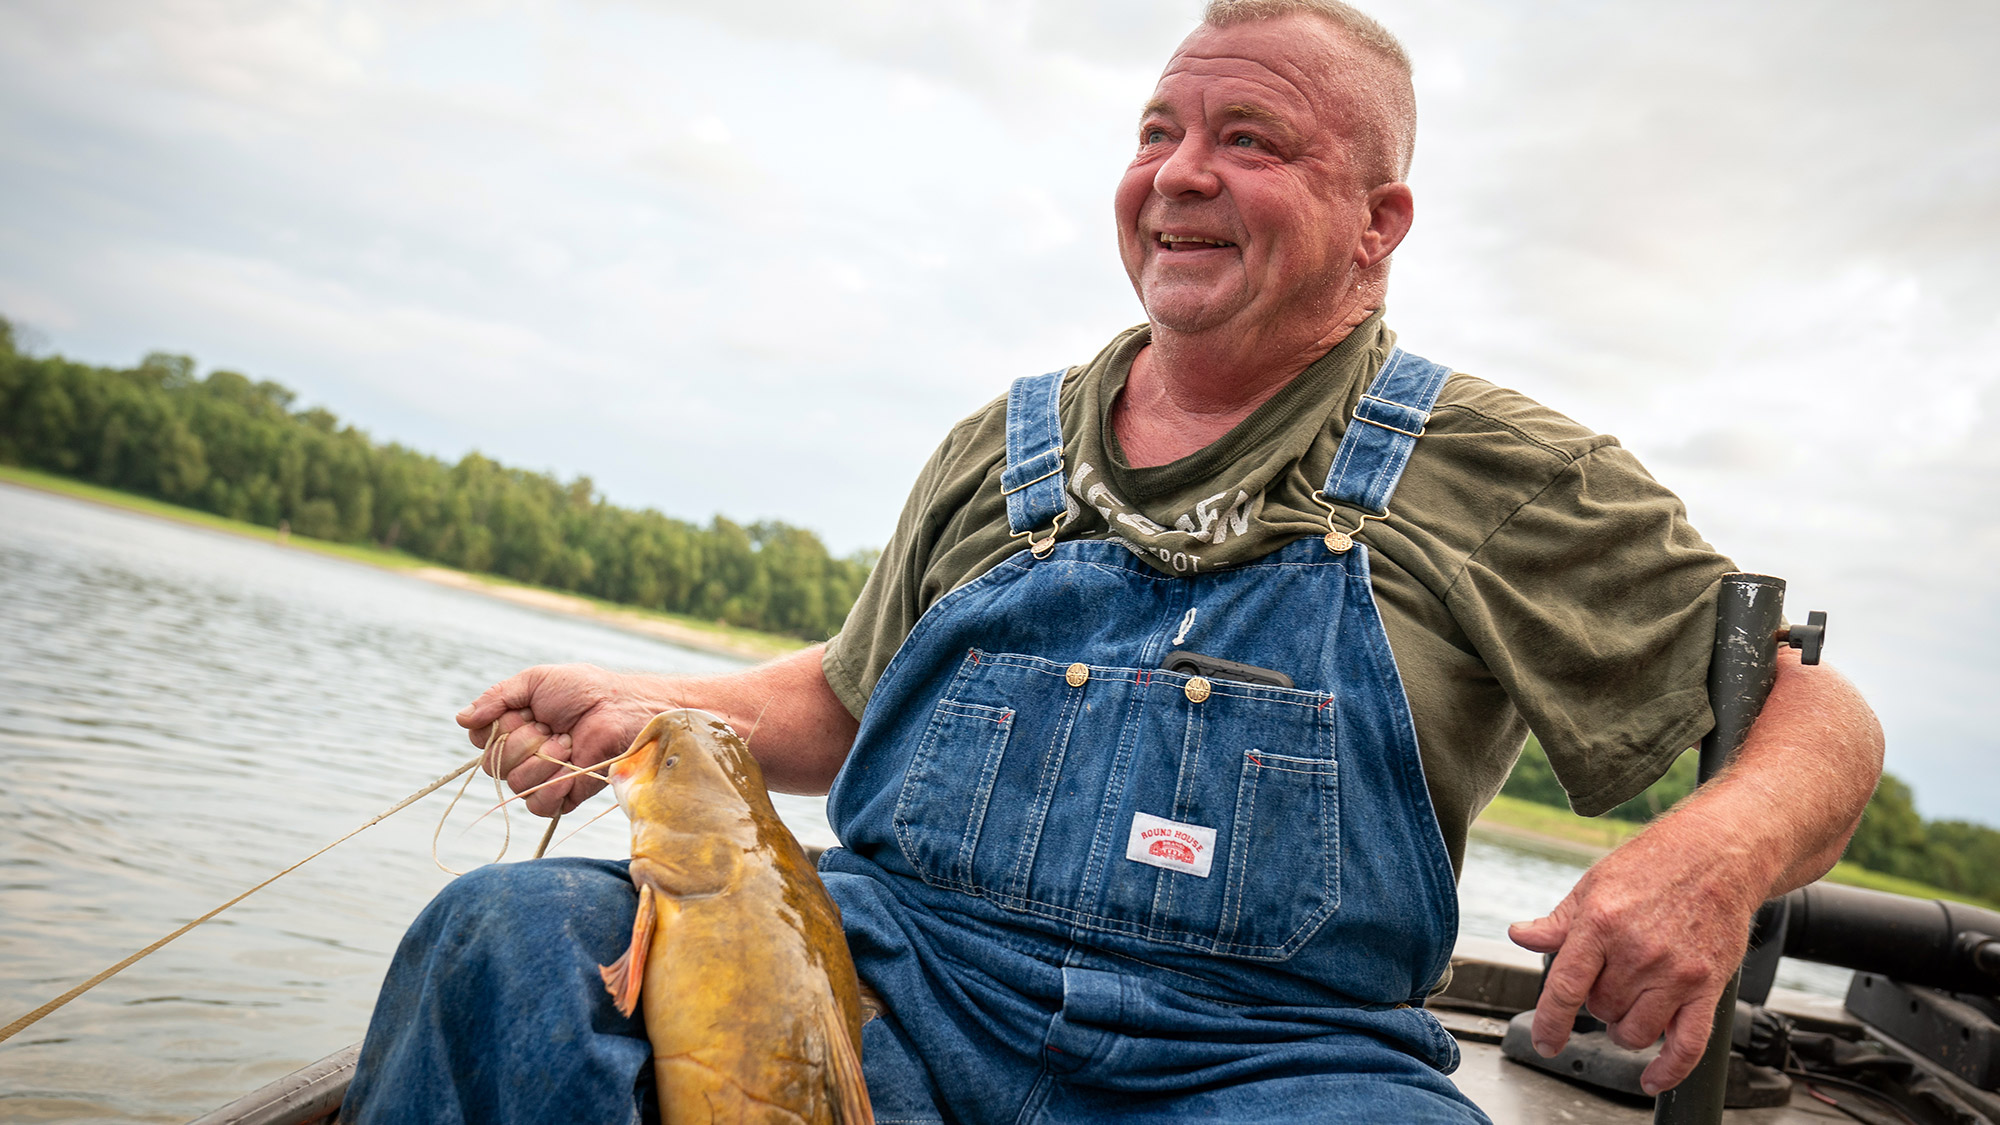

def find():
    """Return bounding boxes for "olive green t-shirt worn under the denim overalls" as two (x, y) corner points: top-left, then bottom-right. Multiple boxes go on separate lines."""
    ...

(826, 312), (1734, 869)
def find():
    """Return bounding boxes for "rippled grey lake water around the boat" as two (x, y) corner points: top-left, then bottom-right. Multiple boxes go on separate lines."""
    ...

(0, 484), (1846, 1121)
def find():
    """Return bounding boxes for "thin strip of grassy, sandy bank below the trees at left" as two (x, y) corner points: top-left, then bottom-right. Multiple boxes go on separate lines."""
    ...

(0, 464), (804, 661)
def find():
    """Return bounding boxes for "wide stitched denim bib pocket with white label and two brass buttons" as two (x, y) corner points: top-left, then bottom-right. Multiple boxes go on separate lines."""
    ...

(894, 651), (1340, 961)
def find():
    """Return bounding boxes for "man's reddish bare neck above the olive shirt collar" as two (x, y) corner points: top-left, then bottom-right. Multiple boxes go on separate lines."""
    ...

(1112, 300), (1374, 468)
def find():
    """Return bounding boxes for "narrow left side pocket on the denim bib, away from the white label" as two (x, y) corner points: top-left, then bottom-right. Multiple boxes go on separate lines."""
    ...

(896, 699), (1014, 895)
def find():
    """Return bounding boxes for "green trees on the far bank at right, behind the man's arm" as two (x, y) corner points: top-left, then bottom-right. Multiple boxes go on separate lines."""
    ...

(1500, 739), (2000, 903)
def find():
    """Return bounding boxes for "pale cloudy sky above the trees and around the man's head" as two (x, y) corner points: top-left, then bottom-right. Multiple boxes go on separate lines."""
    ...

(0, 0), (2000, 827)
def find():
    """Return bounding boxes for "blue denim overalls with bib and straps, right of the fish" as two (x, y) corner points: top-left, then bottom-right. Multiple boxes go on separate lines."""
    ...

(822, 350), (1484, 1123)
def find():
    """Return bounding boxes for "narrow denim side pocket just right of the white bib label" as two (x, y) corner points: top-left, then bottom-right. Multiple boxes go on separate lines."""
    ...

(1218, 751), (1340, 959)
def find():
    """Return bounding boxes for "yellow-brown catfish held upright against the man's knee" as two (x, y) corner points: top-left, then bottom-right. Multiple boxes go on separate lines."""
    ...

(604, 711), (874, 1125)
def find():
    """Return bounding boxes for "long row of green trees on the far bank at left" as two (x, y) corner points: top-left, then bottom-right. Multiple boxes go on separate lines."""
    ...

(0, 318), (876, 641)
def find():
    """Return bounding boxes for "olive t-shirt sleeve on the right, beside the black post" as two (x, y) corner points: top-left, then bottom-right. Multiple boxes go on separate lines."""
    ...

(1446, 444), (1734, 817)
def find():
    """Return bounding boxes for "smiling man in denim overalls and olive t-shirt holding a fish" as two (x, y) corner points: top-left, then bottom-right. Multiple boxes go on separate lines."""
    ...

(336, 0), (1880, 1121)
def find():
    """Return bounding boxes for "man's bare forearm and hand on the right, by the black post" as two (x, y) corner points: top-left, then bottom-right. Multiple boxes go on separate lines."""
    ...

(1508, 649), (1882, 1093)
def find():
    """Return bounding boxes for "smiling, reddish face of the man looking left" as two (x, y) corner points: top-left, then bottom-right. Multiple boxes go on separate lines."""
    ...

(1116, 16), (1370, 336)
